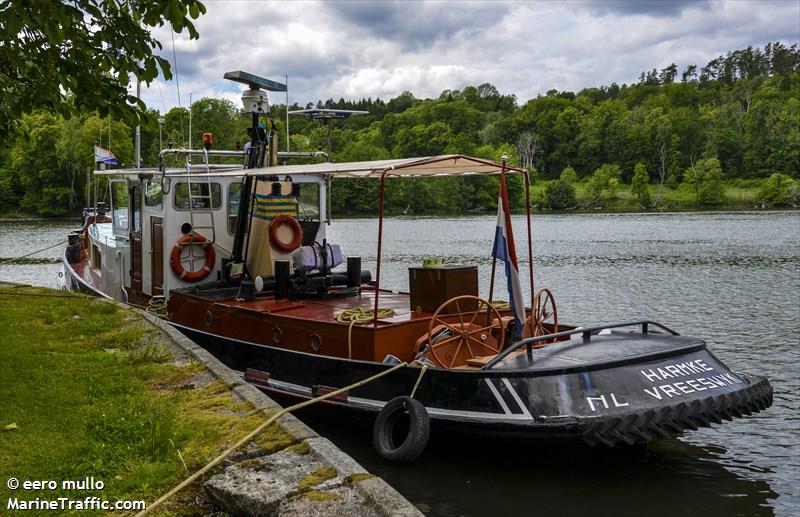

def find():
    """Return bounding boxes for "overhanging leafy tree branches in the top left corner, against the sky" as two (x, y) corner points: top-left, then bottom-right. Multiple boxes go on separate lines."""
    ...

(0, 0), (206, 141)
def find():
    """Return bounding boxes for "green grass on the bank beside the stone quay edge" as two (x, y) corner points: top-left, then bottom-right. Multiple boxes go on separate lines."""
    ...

(0, 286), (268, 515)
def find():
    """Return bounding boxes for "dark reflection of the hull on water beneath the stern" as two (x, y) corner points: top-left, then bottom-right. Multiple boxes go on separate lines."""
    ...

(301, 411), (778, 516)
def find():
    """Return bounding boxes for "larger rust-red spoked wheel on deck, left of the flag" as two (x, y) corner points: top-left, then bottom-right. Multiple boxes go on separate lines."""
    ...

(426, 295), (505, 368)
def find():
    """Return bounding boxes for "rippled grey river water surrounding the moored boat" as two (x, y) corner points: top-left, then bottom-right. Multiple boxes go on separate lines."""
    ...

(0, 212), (800, 516)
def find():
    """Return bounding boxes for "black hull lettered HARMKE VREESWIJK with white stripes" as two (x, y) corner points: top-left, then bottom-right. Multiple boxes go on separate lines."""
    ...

(175, 325), (772, 446)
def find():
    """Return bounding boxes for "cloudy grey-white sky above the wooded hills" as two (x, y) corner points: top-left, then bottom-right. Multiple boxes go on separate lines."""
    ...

(142, 0), (800, 113)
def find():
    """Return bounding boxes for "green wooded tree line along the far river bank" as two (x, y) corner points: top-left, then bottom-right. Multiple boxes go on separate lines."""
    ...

(0, 42), (800, 215)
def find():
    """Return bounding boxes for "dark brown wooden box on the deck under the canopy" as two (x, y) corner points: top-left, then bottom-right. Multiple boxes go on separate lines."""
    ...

(408, 265), (478, 314)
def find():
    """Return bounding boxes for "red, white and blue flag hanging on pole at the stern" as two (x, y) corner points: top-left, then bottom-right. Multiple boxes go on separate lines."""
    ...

(492, 171), (525, 336)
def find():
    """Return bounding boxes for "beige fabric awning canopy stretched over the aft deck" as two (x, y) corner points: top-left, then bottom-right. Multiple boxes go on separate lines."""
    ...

(199, 154), (523, 178)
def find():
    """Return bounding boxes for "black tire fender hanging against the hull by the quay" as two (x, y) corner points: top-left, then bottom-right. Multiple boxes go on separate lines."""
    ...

(372, 396), (431, 461)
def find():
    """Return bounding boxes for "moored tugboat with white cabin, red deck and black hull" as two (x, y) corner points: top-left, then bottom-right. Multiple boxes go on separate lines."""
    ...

(64, 72), (772, 460)
